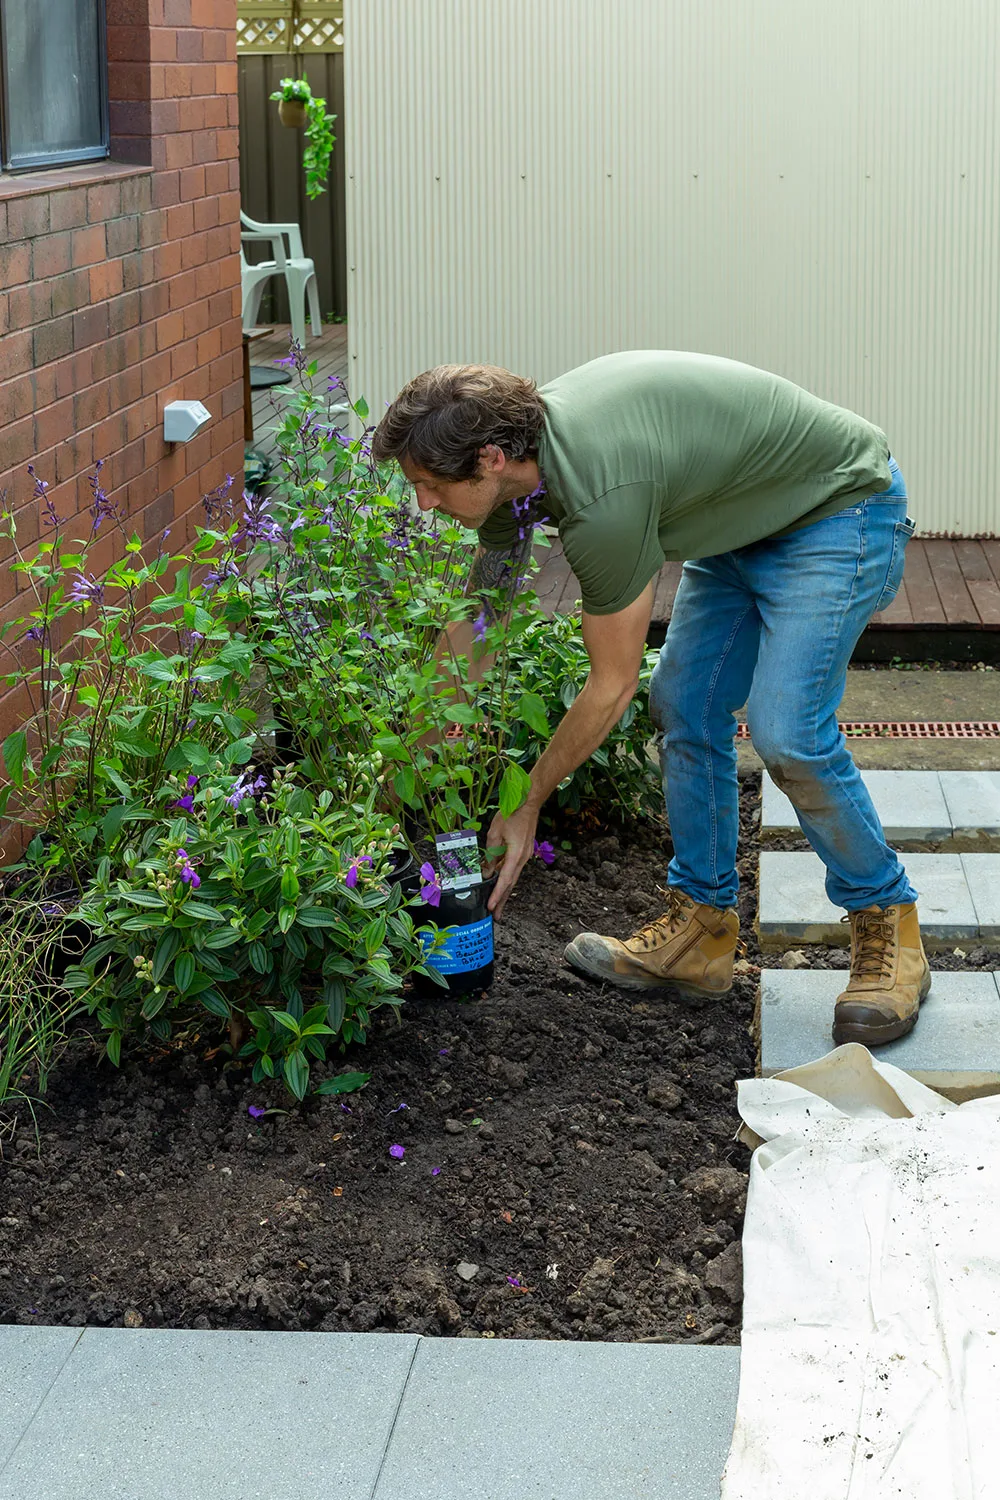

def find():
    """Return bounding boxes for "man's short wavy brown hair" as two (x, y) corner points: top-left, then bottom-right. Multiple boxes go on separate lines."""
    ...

(372, 365), (546, 480)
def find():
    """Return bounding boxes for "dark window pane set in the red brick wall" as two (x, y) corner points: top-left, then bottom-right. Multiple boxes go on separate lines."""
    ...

(0, 0), (106, 167)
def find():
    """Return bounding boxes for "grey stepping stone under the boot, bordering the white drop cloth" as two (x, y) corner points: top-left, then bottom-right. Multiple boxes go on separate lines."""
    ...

(760, 969), (1000, 1101)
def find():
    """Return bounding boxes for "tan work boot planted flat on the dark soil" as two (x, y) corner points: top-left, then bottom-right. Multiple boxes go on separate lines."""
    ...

(565, 887), (739, 995)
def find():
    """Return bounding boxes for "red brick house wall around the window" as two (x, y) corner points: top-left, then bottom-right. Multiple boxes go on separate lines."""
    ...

(0, 0), (243, 735)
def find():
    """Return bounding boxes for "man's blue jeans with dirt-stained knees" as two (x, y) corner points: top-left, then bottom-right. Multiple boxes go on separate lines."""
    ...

(649, 462), (916, 911)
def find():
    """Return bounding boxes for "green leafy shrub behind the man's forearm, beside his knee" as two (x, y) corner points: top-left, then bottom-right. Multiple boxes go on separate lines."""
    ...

(510, 615), (663, 819)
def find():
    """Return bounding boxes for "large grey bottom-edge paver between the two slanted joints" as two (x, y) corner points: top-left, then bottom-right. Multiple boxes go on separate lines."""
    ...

(0, 1328), (427, 1500)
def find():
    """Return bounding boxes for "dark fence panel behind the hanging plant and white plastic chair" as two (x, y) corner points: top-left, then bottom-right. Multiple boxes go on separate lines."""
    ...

(238, 53), (348, 323)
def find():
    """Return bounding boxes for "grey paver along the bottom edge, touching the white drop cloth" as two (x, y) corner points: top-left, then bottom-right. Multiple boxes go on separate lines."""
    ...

(373, 1340), (739, 1500)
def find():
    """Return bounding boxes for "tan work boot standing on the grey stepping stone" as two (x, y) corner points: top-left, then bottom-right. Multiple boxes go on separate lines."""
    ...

(834, 902), (931, 1047)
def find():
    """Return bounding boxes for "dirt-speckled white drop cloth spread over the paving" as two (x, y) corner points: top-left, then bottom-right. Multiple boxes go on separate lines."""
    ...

(723, 1046), (1000, 1500)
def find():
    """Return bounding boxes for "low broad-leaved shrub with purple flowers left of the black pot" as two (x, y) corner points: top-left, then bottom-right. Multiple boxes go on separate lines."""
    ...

(66, 762), (424, 1098)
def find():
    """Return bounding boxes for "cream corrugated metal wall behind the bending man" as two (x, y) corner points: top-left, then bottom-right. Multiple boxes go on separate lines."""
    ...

(345, 0), (1000, 536)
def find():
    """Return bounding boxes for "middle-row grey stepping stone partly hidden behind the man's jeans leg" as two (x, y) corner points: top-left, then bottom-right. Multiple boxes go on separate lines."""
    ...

(757, 851), (977, 948)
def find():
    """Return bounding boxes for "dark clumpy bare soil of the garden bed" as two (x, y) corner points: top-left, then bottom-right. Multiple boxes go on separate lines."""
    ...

(0, 777), (1000, 1343)
